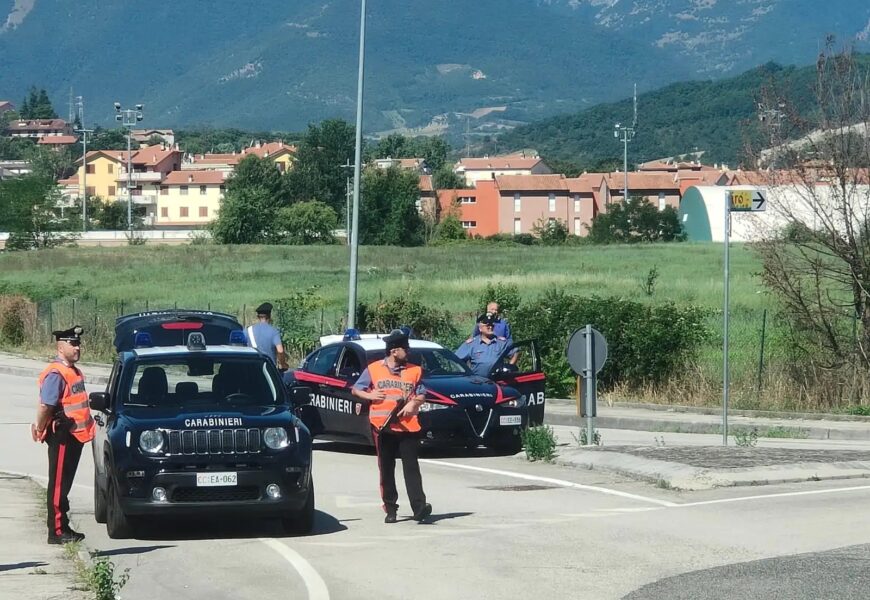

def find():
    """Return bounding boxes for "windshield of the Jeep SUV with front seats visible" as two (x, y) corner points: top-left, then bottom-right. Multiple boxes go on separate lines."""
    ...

(120, 355), (283, 408)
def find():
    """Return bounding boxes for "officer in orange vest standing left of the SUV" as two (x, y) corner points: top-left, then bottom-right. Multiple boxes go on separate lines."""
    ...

(31, 325), (95, 544)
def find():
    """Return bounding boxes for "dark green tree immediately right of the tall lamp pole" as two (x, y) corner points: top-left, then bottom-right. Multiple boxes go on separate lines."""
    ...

(359, 168), (424, 246)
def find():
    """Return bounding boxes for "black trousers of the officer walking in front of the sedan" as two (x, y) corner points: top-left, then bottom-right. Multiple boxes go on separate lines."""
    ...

(373, 431), (426, 513)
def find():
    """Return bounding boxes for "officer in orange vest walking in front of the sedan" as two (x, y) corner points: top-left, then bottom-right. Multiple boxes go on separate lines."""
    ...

(353, 329), (432, 523)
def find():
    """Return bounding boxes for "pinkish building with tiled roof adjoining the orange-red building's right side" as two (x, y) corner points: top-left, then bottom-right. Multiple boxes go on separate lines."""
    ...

(495, 174), (581, 234)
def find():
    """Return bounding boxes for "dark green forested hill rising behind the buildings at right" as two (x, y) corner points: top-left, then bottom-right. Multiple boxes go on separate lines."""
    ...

(498, 54), (870, 172)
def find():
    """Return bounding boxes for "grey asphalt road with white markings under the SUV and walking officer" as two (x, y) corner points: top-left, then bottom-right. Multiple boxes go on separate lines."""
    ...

(0, 375), (870, 600)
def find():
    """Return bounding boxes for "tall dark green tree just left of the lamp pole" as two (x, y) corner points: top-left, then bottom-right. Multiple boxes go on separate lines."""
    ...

(288, 119), (355, 215)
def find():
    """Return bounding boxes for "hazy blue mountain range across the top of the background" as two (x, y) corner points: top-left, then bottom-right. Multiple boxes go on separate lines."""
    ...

(0, 0), (870, 139)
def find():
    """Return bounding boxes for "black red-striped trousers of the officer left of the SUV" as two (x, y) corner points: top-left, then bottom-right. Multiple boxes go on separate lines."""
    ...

(45, 433), (84, 535)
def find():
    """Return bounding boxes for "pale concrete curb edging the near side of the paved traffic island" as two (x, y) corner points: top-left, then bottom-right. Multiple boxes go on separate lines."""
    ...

(555, 450), (870, 491)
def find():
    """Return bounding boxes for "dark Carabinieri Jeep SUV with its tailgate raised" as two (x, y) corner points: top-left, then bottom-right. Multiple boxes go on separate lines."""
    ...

(90, 310), (317, 538)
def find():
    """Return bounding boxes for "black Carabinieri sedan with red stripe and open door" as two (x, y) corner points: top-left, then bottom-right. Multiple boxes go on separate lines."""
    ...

(285, 335), (544, 452)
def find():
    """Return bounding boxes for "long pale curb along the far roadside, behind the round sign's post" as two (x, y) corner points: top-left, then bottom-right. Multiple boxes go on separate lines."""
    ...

(544, 413), (870, 441)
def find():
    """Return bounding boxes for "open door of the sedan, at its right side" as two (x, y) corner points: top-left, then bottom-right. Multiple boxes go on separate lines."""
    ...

(489, 340), (546, 426)
